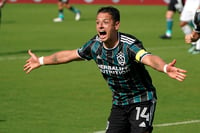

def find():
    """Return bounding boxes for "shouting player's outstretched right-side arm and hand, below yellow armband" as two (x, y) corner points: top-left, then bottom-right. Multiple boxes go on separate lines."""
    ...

(142, 55), (187, 81)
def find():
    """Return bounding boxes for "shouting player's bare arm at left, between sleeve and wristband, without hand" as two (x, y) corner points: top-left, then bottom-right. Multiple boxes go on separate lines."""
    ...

(43, 50), (79, 65)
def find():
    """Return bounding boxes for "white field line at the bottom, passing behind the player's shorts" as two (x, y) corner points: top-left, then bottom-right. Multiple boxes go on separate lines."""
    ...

(94, 120), (200, 133)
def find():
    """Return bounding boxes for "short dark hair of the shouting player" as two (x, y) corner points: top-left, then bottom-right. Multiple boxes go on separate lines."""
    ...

(97, 6), (120, 22)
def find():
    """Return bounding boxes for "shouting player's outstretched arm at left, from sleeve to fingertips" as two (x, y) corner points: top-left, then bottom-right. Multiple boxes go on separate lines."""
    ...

(24, 50), (81, 73)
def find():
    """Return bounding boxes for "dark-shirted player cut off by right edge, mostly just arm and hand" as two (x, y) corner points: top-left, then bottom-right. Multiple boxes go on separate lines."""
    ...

(185, 9), (200, 53)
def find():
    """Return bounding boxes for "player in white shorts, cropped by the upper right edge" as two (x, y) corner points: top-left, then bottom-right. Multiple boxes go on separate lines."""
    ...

(180, 0), (200, 54)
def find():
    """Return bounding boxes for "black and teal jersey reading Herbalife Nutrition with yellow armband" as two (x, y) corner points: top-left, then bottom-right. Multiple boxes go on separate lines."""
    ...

(78, 32), (156, 105)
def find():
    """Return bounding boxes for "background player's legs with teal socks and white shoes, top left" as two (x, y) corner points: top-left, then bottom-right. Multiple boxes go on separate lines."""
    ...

(53, 0), (81, 22)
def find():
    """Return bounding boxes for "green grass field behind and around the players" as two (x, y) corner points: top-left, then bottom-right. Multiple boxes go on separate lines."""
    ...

(0, 4), (200, 133)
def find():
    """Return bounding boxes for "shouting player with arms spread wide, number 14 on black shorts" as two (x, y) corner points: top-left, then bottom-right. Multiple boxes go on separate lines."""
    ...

(24, 6), (186, 133)
